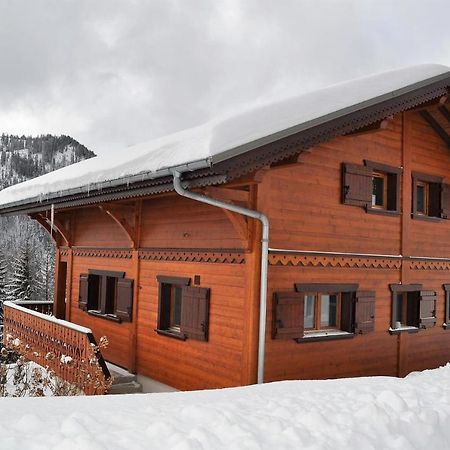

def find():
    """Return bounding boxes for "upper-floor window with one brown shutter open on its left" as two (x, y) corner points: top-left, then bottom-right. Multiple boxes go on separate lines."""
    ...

(342, 160), (401, 214)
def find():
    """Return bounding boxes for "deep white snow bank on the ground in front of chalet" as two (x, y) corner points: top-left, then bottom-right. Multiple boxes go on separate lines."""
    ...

(0, 365), (450, 450)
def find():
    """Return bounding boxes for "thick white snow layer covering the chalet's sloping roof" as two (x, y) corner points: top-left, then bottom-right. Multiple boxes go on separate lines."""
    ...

(0, 64), (450, 208)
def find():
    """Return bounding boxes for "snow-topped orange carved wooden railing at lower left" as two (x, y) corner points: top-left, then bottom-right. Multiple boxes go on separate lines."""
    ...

(3, 302), (111, 395)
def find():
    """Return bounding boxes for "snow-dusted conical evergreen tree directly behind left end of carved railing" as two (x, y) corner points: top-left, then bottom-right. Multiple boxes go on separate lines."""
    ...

(7, 241), (32, 301)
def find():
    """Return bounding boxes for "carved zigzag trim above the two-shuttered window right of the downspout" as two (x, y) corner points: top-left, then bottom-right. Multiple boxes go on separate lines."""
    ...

(269, 254), (401, 269)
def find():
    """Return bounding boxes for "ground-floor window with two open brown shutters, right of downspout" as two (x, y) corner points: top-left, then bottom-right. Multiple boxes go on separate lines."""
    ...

(272, 284), (375, 341)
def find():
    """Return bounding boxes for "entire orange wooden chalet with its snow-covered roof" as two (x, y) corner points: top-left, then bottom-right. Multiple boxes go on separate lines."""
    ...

(0, 66), (450, 390)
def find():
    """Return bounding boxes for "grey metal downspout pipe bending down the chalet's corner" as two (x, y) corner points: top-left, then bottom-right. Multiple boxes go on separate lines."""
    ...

(172, 170), (269, 384)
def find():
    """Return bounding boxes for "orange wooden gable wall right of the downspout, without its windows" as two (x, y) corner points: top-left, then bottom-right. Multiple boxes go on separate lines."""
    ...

(258, 113), (450, 381)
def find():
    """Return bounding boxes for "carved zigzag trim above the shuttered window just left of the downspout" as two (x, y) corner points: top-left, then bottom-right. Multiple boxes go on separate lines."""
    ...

(139, 249), (245, 264)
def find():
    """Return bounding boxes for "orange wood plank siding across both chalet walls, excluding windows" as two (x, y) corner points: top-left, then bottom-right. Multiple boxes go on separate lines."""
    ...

(50, 112), (450, 390)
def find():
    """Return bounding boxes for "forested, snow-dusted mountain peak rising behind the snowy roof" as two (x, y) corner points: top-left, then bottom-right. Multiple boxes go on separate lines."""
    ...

(0, 134), (95, 189)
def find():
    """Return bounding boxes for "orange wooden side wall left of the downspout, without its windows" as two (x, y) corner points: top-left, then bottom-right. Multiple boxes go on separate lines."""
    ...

(62, 194), (253, 390)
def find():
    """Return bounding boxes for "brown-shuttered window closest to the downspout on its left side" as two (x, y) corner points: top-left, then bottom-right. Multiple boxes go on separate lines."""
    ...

(156, 275), (210, 341)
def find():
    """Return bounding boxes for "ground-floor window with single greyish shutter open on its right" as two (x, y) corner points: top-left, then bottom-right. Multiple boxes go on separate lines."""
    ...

(390, 284), (436, 331)
